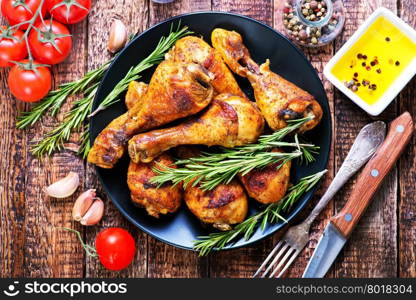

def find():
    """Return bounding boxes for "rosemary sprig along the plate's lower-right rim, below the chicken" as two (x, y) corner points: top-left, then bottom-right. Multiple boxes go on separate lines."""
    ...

(194, 170), (327, 256)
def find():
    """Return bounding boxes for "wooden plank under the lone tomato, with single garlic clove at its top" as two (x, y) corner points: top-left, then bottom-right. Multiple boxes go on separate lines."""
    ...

(85, 0), (148, 277)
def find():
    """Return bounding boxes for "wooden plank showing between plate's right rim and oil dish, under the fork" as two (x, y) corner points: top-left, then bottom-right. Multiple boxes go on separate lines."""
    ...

(269, 0), (335, 277)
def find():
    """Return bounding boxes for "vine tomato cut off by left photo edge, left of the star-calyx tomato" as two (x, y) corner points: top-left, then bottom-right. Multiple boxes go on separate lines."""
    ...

(0, 26), (27, 67)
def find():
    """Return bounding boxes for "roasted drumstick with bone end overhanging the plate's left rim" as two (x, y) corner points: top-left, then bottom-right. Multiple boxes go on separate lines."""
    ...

(88, 61), (214, 168)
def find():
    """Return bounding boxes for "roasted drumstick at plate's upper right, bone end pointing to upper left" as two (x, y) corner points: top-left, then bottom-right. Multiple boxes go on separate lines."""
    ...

(211, 28), (322, 132)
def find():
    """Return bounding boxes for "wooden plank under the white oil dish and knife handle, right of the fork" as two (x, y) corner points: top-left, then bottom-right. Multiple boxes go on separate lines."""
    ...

(335, 0), (397, 277)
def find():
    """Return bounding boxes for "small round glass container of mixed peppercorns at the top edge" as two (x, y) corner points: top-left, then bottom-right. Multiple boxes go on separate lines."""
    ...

(283, 0), (345, 47)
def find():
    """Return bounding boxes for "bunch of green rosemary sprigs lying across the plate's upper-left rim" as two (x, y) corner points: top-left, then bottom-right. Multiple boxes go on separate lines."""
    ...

(28, 24), (193, 158)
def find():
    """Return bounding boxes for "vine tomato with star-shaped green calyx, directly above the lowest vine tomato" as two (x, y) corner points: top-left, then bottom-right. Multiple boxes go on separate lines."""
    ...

(29, 20), (72, 65)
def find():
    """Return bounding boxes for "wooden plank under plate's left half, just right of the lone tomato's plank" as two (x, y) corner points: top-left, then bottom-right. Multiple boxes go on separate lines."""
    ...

(147, 0), (211, 278)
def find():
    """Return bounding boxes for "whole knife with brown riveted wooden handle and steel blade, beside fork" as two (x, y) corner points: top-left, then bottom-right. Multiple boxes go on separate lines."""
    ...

(302, 112), (414, 278)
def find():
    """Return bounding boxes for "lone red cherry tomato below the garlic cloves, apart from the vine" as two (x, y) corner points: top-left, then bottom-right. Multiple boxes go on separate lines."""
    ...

(95, 227), (136, 271)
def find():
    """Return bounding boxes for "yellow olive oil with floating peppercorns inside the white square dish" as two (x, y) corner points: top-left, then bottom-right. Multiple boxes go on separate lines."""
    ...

(331, 16), (416, 105)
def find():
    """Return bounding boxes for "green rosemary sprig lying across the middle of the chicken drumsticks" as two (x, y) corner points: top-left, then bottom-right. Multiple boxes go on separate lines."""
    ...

(151, 118), (319, 190)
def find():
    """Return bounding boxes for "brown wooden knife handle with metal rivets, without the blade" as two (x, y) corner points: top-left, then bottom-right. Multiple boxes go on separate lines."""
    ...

(330, 112), (414, 238)
